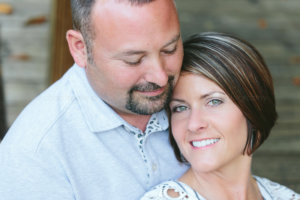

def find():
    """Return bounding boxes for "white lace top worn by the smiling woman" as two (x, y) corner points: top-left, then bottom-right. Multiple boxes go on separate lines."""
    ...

(141, 176), (300, 200)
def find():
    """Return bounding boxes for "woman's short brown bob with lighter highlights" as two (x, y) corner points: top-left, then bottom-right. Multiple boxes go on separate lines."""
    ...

(170, 32), (277, 162)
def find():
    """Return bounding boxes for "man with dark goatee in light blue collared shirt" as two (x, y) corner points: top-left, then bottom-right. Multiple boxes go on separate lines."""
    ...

(0, 0), (186, 200)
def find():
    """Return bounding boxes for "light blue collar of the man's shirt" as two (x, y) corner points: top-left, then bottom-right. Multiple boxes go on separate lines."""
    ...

(69, 64), (169, 132)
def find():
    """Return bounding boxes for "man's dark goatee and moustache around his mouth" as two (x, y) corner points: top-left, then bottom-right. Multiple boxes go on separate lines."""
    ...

(126, 76), (174, 115)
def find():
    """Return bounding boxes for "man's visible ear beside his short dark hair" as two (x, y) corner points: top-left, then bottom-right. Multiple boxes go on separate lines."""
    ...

(66, 30), (87, 67)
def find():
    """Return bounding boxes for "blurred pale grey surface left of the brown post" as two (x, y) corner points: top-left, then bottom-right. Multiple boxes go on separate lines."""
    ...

(0, 0), (52, 125)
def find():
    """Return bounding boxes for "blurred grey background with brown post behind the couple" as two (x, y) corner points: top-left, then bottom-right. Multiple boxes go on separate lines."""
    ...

(0, 0), (300, 193)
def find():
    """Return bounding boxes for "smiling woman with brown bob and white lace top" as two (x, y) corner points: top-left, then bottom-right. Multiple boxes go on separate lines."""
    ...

(142, 33), (300, 200)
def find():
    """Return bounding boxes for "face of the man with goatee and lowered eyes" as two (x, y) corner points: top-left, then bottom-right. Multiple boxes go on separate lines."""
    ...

(86, 0), (183, 115)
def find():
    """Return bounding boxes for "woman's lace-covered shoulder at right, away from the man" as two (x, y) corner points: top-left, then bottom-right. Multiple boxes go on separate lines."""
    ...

(254, 176), (300, 200)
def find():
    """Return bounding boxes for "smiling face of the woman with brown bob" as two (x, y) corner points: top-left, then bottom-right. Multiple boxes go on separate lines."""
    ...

(170, 73), (247, 172)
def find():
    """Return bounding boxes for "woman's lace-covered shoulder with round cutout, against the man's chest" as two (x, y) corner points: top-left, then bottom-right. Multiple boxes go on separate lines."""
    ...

(141, 180), (200, 200)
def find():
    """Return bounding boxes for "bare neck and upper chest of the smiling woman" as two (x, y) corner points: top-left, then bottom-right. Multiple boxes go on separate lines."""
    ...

(179, 158), (262, 200)
